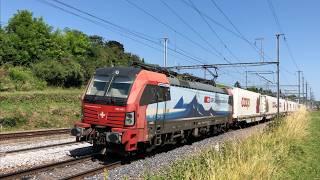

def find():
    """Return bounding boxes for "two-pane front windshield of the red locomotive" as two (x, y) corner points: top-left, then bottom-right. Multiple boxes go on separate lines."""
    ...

(86, 75), (132, 98)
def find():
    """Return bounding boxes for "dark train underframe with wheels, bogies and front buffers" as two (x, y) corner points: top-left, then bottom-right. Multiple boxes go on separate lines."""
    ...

(72, 114), (284, 156)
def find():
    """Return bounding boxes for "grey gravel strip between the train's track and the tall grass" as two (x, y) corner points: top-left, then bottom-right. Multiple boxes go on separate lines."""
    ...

(87, 123), (267, 179)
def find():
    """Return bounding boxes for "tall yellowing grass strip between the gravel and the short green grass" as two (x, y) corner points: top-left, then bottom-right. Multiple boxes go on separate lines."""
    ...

(145, 109), (309, 179)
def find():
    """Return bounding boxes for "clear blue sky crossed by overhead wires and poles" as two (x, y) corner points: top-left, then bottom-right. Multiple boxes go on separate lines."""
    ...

(0, 0), (320, 100)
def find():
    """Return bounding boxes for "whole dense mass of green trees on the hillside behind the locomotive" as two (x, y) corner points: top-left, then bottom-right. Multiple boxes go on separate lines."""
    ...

(0, 10), (141, 87)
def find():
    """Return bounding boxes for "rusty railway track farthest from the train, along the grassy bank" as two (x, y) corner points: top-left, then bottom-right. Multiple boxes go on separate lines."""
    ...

(0, 128), (70, 141)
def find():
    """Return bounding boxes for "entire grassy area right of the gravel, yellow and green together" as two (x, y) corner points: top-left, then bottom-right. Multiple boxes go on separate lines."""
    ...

(145, 110), (320, 179)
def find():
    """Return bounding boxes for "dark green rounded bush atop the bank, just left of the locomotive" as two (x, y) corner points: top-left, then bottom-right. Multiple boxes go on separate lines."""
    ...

(33, 60), (84, 87)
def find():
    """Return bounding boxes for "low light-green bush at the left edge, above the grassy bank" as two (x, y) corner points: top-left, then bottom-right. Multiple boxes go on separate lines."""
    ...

(0, 67), (47, 91)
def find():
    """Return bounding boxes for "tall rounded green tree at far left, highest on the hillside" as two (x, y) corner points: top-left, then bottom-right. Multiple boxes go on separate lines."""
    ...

(5, 10), (52, 66)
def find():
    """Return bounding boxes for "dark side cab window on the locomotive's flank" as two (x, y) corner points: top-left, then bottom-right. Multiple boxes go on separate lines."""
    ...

(140, 84), (171, 105)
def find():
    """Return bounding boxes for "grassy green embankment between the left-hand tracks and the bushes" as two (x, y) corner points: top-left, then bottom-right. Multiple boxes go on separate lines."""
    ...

(0, 88), (82, 132)
